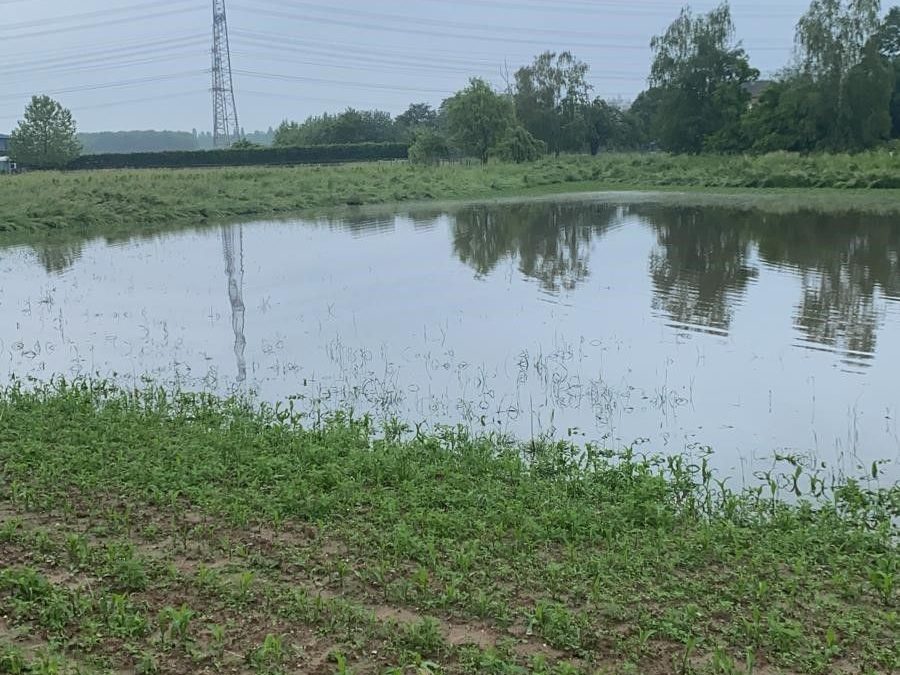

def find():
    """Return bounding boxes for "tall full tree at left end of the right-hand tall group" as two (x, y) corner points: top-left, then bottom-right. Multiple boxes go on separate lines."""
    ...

(650, 2), (759, 152)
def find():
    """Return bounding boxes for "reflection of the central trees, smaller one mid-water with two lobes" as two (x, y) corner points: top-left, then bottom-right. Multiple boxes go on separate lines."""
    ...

(452, 202), (621, 291)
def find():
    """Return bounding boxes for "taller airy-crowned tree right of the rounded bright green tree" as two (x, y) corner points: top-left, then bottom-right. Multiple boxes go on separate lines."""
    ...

(514, 52), (591, 155)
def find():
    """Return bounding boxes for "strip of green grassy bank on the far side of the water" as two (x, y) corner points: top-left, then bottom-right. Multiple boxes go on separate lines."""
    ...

(0, 153), (900, 232)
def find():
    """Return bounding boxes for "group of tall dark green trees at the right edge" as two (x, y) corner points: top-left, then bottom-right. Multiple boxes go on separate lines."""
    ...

(631, 0), (900, 152)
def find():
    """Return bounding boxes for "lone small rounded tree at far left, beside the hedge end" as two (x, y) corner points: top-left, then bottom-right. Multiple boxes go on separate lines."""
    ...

(9, 96), (81, 169)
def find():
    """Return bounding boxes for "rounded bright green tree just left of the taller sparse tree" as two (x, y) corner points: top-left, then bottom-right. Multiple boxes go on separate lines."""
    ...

(444, 78), (515, 164)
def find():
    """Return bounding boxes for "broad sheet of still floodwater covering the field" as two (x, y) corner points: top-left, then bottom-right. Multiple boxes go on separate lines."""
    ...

(0, 196), (900, 477)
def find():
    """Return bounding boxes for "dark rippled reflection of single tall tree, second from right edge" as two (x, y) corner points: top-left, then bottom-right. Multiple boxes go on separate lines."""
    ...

(632, 205), (759, 332)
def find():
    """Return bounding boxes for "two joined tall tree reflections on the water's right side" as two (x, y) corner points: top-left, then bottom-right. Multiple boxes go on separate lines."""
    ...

(632, 206), (900, 362)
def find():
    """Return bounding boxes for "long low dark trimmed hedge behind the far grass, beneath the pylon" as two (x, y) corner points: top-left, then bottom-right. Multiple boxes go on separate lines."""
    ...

(66, 143), (409, 171)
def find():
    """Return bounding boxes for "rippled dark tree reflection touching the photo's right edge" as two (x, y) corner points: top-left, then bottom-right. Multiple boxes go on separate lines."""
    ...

(757, 213), (900, 362)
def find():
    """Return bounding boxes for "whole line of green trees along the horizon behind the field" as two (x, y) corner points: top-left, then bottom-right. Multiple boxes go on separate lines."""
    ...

(10, 0), (900, 168)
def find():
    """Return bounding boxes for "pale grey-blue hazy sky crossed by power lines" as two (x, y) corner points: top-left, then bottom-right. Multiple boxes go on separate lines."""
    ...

(0, 0), (808, 133)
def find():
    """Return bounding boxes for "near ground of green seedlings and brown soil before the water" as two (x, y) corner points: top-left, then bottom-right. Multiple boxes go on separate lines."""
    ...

(0, 384), (900, 673)
